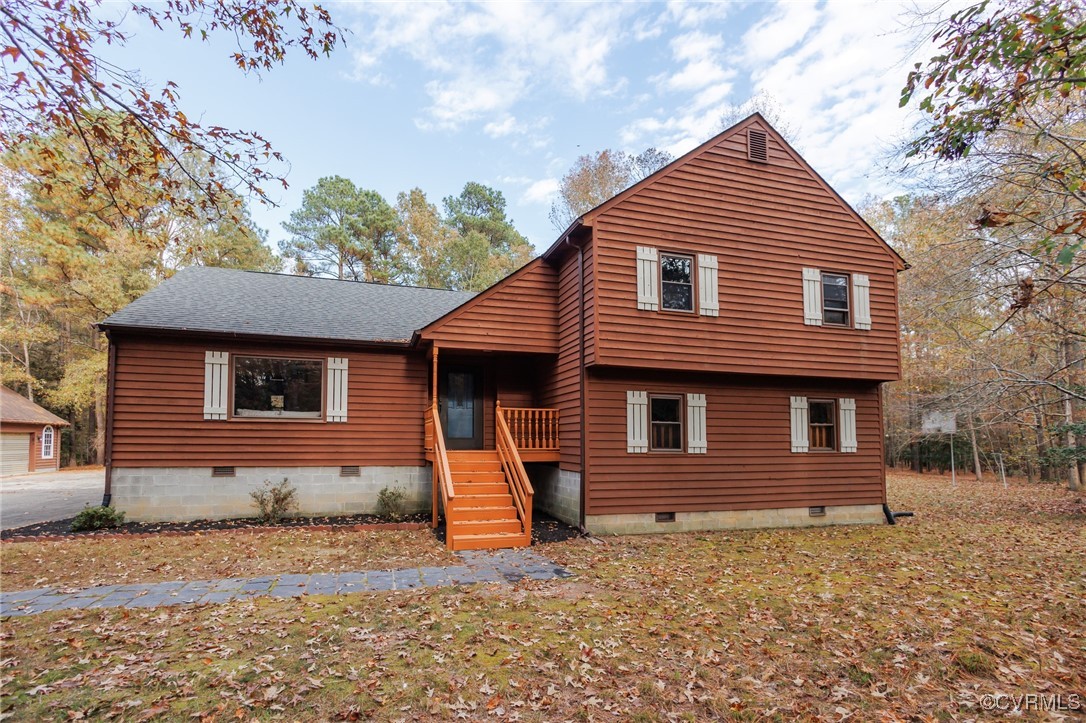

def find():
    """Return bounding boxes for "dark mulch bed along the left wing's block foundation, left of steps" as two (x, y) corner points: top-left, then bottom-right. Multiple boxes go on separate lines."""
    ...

(0, 505), (430, 541)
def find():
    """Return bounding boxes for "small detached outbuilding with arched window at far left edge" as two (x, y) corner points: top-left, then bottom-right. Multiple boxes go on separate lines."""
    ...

(0, 386), (68, 477)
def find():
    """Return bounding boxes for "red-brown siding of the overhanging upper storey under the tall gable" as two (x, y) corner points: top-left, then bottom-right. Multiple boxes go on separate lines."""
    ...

(593, 119), (900, 381)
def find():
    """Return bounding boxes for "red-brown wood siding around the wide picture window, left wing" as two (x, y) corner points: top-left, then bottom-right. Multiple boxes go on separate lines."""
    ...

(113, 338), (428, 467)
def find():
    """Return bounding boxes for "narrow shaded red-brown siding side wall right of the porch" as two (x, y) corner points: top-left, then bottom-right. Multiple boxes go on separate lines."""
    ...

(539, 250), (591, 472)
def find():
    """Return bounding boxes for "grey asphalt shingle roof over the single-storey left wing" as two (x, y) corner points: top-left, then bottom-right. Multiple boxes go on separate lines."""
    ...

(100, 267), (475, 342)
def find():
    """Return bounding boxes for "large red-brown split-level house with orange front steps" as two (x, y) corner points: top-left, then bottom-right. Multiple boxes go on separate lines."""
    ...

(101, 115), (905, 548)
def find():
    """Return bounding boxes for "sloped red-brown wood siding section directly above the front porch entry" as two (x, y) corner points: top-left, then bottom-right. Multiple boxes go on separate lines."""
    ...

(420, 258), (558, 354)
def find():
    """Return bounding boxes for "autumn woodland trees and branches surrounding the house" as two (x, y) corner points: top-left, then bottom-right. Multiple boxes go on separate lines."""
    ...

(0, 0), (1086, 489)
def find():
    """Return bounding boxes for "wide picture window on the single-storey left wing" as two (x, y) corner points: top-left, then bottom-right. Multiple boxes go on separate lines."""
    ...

(233, 356), (324, 419)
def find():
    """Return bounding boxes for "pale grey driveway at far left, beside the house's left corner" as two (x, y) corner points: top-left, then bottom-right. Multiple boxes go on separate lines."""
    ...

(0, 468), (105, 530)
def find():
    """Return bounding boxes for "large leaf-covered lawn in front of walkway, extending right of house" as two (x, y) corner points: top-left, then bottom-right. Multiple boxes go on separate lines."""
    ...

(0, 474), (1086, 721)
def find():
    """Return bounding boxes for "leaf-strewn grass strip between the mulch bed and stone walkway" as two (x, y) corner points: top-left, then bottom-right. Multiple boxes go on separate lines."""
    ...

(0, 530), (459, 591)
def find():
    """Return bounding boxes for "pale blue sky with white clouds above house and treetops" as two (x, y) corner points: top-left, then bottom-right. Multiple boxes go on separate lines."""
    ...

(105, 0), (951, 251)
